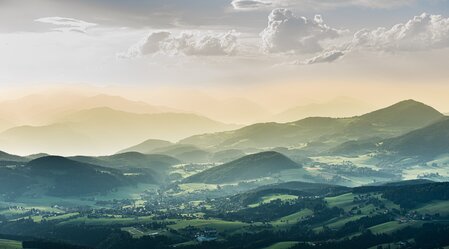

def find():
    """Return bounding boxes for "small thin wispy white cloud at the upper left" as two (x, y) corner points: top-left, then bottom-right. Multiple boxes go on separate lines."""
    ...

(34, 16), (97, 33)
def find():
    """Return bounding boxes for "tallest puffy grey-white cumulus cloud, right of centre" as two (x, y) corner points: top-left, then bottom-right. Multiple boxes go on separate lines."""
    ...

(260, 9), (343, 54)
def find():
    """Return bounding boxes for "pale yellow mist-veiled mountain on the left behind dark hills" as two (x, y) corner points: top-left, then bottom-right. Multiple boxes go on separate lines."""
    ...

(0, 107), (235, 155)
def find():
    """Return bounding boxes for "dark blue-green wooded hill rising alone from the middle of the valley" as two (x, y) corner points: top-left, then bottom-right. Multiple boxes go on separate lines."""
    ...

(186, 151), (301, 183)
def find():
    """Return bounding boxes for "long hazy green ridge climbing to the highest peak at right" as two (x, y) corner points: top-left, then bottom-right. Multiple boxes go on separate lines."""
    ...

(180, 100), (444, 150)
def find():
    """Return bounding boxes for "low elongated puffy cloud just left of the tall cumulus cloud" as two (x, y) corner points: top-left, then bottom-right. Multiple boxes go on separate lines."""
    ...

(126, 31), (237, 57)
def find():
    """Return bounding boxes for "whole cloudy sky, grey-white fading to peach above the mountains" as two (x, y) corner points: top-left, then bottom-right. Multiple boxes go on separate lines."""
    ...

(0, 0), (449, 111)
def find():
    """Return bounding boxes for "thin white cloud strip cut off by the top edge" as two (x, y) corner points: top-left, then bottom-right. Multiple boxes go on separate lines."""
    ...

(231, 0), (416, 10)
